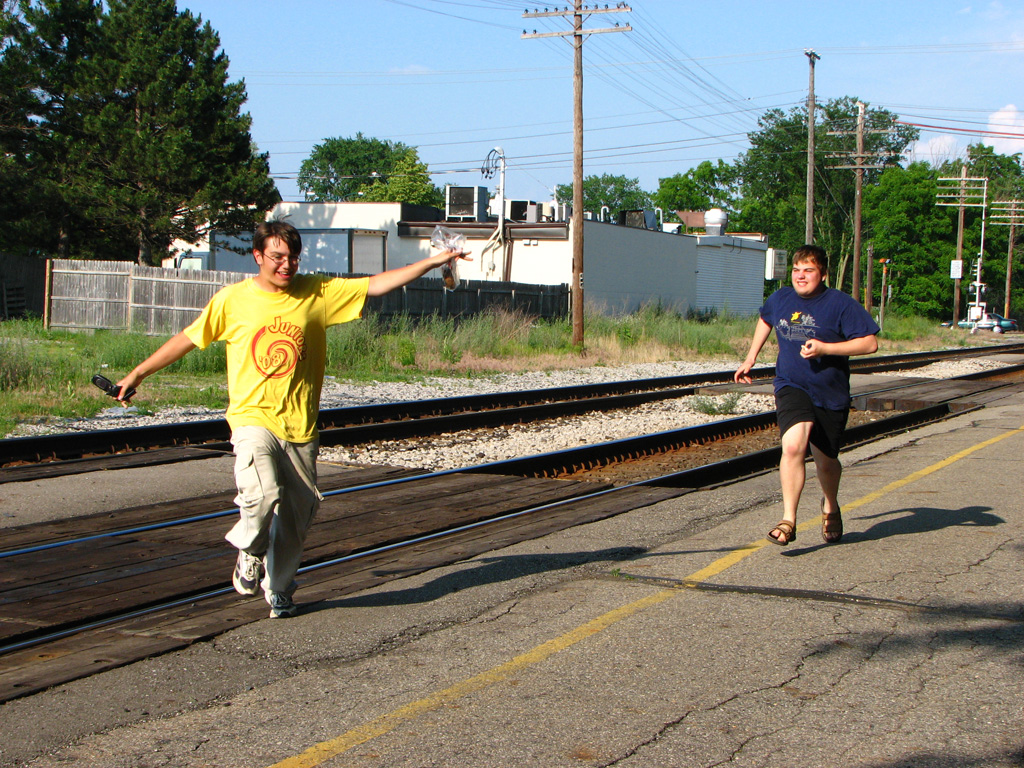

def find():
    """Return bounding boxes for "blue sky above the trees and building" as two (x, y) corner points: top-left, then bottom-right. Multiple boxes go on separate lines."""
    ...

(178, 0), (1024, 202)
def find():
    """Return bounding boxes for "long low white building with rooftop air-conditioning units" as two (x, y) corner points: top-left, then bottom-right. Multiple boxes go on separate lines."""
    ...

(169, 202), (774, 314)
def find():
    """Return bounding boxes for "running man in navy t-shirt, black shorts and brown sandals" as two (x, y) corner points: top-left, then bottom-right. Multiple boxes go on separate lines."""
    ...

(733, 245), (880, 547)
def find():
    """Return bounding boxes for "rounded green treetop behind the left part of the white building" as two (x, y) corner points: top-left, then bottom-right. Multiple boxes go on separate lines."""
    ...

(298, 133), (444, 206)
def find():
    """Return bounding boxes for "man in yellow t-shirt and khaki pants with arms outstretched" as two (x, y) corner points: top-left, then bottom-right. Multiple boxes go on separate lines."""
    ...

(118, 221), (467, 618)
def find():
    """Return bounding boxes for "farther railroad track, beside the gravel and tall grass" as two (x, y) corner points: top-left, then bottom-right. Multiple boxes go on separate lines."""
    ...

(0, 343), (1024, 475)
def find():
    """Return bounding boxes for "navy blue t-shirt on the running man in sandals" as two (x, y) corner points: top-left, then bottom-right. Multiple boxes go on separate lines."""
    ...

(761, 286), (880, 411)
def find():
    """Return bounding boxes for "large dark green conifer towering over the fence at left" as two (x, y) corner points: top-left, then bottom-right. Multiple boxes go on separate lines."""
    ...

(0, 0), (280, 263)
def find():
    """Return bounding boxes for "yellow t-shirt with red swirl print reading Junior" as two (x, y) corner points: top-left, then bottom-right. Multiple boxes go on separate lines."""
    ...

(184, 274), (370, 442)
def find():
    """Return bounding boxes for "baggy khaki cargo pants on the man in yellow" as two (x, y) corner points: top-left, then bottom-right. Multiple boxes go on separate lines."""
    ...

(224, 427), (324, 594)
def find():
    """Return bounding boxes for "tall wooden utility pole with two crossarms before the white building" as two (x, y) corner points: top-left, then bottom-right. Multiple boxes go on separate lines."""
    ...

(522, 0), (633, 350)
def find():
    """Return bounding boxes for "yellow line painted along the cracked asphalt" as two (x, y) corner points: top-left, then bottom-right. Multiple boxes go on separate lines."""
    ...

(270, 427), (1024, 768)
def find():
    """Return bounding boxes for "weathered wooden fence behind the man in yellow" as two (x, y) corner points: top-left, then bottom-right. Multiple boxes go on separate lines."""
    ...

(45, 259), (569, 336)
